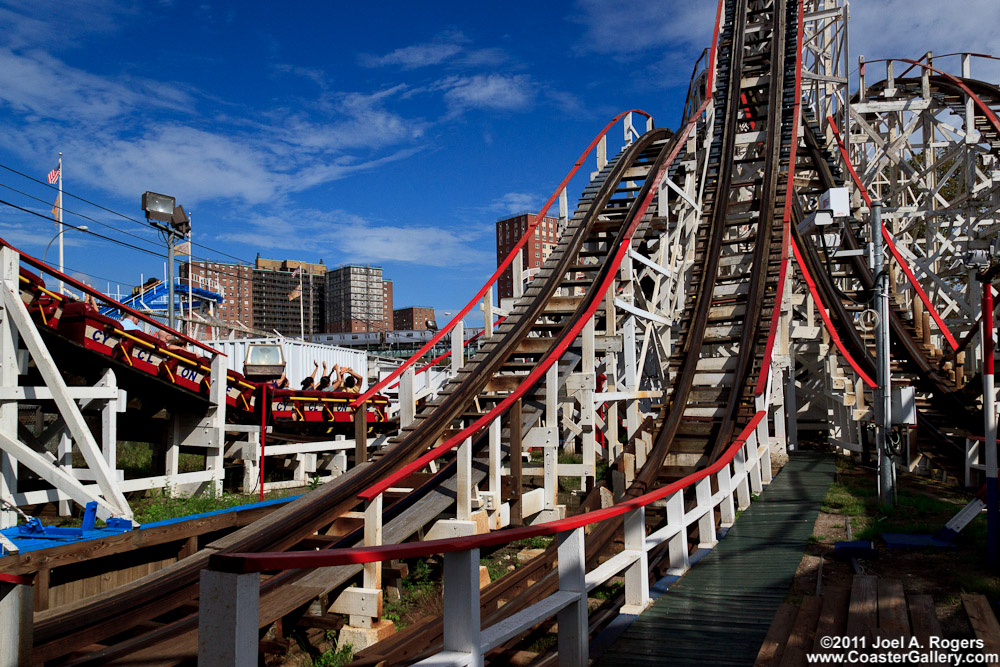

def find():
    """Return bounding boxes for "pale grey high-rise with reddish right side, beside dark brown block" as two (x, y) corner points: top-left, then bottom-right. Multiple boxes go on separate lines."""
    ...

(325, 265), (393, 333)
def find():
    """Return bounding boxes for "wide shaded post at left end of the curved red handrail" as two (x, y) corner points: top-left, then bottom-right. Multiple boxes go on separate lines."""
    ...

(198, 570), (260, 667)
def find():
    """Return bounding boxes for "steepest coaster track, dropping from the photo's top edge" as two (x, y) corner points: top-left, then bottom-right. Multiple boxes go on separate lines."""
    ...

(350, 2), (797, 664)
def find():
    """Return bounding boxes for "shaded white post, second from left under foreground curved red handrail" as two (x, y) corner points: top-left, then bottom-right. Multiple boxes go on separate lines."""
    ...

(444, 549), (483, 665)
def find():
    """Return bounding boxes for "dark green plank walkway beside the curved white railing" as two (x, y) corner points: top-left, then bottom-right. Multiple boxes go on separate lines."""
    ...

(597, 451), (835, 667)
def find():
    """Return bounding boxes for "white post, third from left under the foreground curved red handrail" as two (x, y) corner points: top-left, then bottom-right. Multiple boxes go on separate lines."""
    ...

(556, 527), (589, 667)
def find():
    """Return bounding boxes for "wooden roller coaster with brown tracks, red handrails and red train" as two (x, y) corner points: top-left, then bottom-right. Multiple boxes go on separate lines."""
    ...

(0, 0), (1000, 665)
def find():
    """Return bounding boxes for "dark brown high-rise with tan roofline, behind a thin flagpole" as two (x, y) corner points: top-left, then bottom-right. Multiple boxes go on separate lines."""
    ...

(252, 256), (326, 339)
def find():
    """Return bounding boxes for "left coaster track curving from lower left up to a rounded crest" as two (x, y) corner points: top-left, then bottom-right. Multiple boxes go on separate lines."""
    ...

(35, 117), (688, 664)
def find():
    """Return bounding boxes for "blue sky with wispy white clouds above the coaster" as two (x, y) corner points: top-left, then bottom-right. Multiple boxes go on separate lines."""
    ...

(0, 0), (1000, 328)
